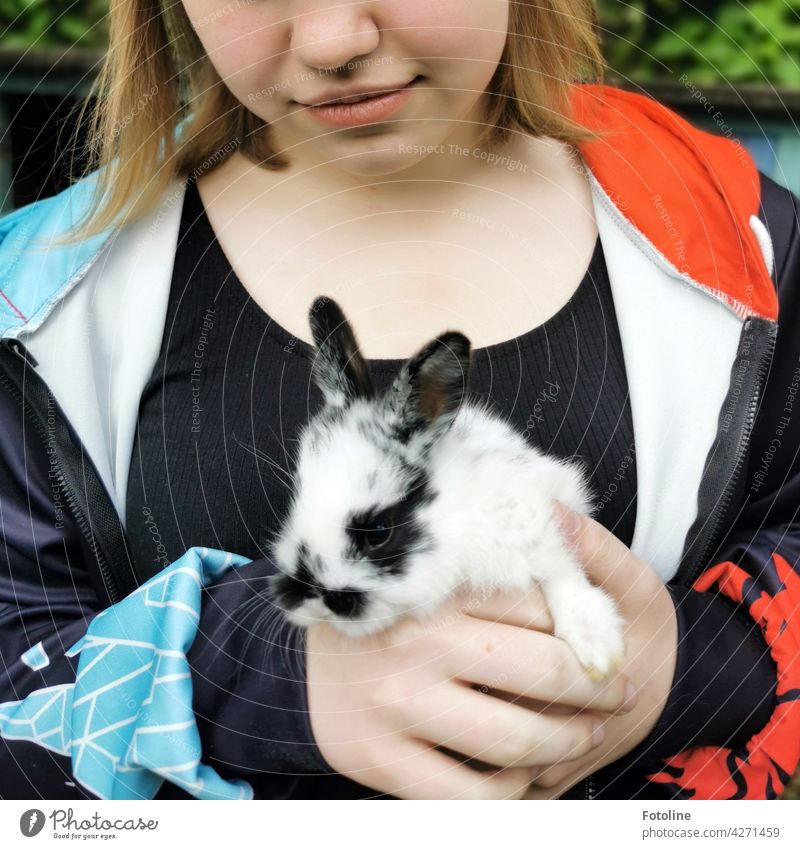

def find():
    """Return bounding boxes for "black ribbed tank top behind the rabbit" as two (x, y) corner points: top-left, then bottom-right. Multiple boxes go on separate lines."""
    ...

(126, 180), (636, 574)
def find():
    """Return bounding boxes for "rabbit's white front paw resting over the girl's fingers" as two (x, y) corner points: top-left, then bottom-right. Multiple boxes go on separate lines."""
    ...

(547, 584), (625, 680)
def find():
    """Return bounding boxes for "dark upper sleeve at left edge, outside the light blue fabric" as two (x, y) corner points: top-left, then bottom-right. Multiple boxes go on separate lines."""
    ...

(0, 368), (100, 799)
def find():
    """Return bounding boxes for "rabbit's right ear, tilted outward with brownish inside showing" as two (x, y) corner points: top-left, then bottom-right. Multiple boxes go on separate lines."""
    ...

(386, 330), (470, 444)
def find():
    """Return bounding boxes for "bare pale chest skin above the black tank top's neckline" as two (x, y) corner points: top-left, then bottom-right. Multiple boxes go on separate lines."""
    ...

(197, 186), (597, 358)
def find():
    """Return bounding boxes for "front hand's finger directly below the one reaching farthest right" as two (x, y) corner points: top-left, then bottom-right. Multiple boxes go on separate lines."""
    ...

(390, 684), (602, 768)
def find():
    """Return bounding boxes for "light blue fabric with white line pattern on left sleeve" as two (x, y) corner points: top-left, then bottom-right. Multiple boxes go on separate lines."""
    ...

(0, 548), (253, 799)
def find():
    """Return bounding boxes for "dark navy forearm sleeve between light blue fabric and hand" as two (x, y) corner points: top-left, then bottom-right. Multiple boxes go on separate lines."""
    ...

(187, 558), (331, 777)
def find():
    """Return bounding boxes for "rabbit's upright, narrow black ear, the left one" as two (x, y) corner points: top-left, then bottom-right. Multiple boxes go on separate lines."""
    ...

(308, 296), (375, 407)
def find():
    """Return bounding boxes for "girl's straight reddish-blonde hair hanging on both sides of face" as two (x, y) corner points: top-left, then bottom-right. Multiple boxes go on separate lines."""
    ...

(63, 0), (604, 242)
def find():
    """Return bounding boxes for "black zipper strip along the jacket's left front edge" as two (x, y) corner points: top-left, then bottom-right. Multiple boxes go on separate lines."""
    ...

(0, 339), (138, 604)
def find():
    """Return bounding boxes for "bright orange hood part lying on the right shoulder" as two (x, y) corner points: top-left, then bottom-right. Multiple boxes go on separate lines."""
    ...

(572, 84), (778, 320)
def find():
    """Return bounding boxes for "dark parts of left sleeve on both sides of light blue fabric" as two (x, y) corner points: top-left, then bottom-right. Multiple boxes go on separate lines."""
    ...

(0, 370), (328, 799)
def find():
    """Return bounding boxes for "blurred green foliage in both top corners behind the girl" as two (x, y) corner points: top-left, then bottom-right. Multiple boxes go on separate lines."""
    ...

(0, 0), (800, 88)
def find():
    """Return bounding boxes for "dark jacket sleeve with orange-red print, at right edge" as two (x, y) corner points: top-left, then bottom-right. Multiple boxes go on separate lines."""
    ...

(649, 175), (800, 799)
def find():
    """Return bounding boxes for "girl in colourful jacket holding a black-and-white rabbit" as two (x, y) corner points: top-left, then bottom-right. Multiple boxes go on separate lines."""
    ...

(0, 0), (800, 799)
